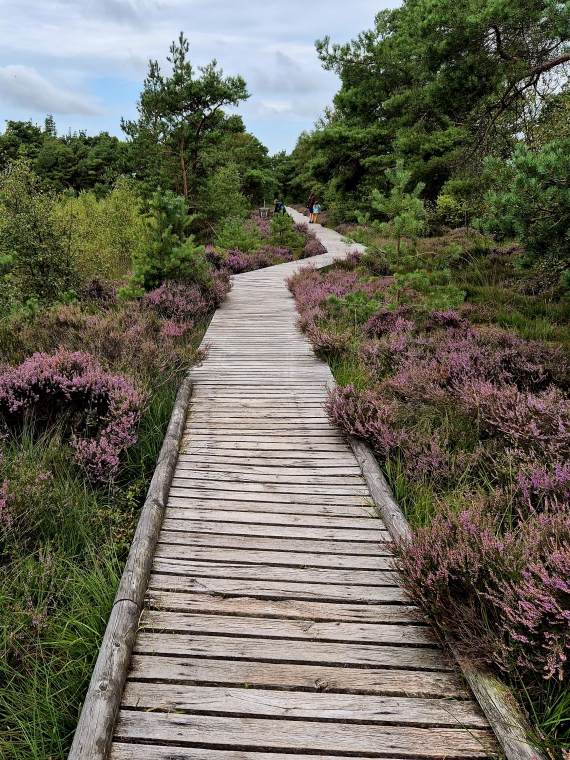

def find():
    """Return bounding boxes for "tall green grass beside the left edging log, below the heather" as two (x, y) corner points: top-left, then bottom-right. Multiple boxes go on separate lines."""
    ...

(0, 322), (207, 760)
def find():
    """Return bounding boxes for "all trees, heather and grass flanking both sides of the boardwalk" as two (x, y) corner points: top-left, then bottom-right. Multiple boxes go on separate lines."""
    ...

(0, 0), (570, 760)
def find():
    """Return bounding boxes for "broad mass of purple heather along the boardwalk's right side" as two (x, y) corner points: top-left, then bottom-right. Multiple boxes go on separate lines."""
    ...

(289, 257), (570, 708)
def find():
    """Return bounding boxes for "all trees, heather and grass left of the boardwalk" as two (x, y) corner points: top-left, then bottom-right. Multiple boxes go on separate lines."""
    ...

(0, 26), (268, 760)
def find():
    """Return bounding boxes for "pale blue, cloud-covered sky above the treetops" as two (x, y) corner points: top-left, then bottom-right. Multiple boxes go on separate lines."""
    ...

(0, 0), (399, 153)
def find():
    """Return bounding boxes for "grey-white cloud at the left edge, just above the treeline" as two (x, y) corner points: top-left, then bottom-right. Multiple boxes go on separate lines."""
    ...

(0, 66), (102, 116)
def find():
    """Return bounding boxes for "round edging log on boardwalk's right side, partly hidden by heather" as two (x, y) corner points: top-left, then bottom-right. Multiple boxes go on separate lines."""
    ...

(349, 436), (546, 760)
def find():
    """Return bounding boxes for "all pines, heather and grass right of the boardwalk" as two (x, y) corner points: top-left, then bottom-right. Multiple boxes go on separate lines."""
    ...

(284, 0), (570, 748)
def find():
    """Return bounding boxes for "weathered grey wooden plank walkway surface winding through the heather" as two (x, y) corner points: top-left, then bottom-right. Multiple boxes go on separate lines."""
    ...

(107, 211), (496, 760)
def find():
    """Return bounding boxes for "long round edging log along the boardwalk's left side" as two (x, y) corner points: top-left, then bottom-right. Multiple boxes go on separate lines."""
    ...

(69, 377), (192, 760)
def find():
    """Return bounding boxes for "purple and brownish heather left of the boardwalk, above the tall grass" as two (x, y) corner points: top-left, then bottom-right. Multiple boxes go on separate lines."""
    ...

(0, 272), (229, 486)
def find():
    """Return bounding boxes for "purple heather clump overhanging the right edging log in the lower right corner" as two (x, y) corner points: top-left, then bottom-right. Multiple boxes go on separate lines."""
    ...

(397, 502), (570, 680)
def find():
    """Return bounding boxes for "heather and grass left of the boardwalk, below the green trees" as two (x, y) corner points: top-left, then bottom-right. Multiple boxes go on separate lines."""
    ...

(0, 254), (225, 757)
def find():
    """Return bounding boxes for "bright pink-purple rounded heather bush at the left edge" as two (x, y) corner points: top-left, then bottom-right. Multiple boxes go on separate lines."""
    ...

(0, 349), (145, 482)
